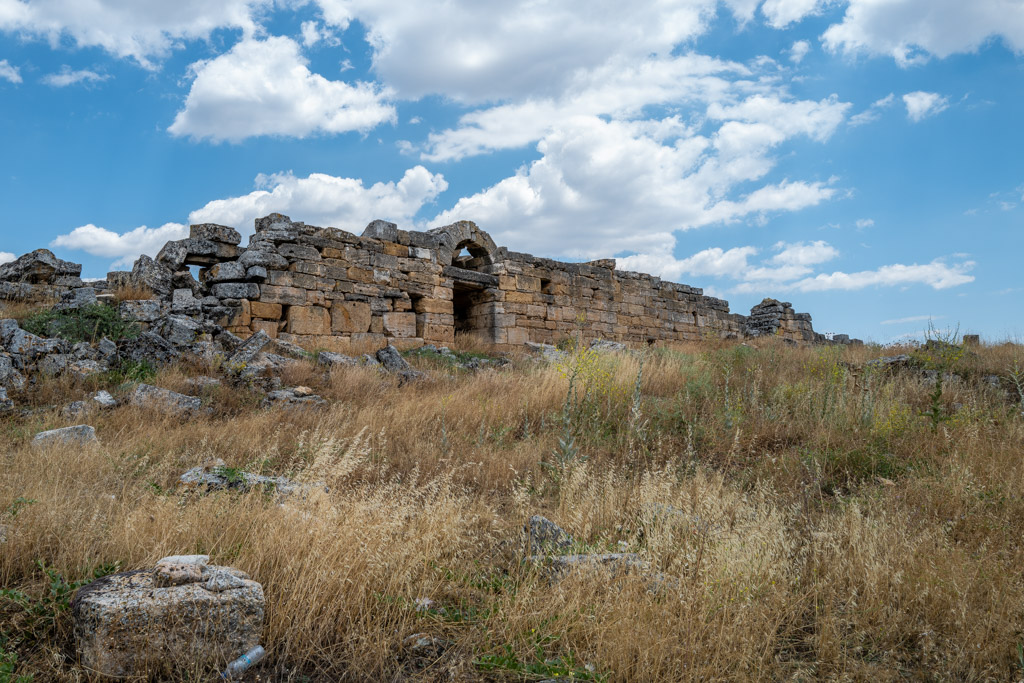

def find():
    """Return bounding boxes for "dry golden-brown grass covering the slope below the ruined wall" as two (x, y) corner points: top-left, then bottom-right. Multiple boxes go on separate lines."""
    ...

(0, 340), (1024, 681)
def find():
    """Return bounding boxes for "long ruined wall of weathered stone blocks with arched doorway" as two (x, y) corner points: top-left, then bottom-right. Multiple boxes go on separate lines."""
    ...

(0, 213), (858, 353)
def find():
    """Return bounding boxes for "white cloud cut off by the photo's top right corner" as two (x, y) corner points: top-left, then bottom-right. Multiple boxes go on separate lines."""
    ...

(819, 0), (1024, 66)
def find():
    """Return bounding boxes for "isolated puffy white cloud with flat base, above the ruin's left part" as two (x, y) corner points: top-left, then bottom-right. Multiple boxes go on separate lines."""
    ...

(168, 37), (395, 141)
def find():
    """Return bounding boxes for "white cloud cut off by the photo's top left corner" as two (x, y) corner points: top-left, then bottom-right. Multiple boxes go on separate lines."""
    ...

(0, 0), (271, 69)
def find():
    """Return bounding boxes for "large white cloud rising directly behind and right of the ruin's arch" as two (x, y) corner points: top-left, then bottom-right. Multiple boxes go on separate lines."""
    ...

(432, 117), (835, 257)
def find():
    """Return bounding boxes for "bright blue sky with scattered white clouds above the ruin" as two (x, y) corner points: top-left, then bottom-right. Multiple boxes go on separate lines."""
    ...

(0, 0), (1024, 342)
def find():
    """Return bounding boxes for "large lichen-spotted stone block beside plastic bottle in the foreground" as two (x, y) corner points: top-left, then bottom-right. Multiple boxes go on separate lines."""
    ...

(72, 556), (264, 677)
